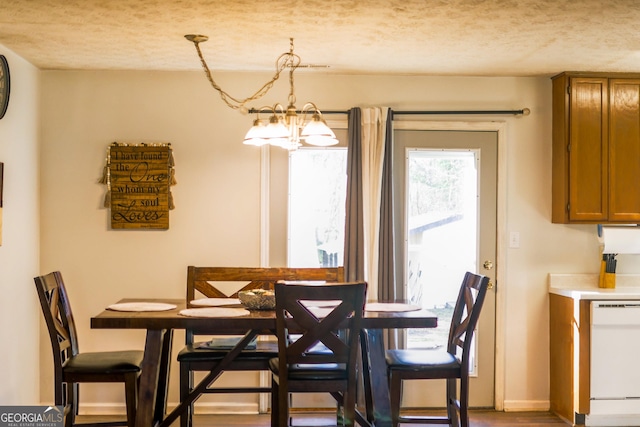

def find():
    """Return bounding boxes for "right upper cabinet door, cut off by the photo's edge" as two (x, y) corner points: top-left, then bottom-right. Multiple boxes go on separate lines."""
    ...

(609, 79), (640, 222)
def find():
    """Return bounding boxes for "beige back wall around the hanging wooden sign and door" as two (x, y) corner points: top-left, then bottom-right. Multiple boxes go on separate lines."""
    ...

(33, 70), (598, 409)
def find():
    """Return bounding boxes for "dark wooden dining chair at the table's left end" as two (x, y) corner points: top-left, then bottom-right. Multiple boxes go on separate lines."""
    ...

(34, 271), (143, 427)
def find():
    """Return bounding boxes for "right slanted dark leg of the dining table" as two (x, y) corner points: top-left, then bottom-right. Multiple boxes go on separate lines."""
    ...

(360, 329), (392, 427)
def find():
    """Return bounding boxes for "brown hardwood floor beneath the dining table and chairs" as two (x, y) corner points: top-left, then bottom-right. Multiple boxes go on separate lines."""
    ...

(78, 410), (569, 427)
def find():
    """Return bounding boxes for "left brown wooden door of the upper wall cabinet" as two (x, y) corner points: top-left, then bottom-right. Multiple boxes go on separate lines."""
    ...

(568, 77), (609, 222)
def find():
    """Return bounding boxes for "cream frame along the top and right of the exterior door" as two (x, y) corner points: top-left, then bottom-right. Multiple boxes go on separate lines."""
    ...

(393, 120), (507, 411)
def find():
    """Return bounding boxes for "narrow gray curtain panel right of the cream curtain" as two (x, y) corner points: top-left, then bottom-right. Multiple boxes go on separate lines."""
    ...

(378, 109), (397, 301)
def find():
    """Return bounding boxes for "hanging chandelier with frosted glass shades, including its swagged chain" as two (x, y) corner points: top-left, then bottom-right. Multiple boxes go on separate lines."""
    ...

(185, 34), (338, 150)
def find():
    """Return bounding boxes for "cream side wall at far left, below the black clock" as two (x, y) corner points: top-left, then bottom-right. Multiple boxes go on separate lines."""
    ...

(0, 45), (40, 405)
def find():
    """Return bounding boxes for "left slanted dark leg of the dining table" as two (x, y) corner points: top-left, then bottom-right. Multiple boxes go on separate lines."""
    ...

(136, 329), (166, 427)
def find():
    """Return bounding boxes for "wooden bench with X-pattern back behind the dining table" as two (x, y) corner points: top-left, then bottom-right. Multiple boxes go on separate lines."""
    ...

(178, 266), (344, 427)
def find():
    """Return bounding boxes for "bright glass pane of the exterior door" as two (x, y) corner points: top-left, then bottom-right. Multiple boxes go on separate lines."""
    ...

(405, 149), (478, 366)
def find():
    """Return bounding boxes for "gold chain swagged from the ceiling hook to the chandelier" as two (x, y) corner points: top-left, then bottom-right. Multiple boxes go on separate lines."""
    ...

(192, 39), (300, 112)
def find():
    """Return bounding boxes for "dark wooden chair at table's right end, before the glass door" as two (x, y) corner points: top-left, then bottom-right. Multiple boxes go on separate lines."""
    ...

(386, 272), (489, 427)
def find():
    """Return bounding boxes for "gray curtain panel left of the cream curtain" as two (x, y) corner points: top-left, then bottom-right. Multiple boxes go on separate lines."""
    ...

(344, 107), (365, 282)
